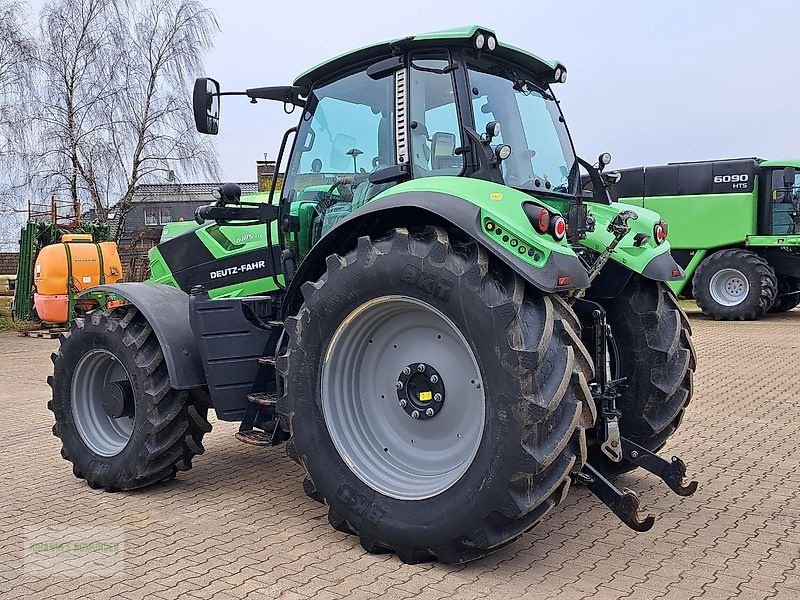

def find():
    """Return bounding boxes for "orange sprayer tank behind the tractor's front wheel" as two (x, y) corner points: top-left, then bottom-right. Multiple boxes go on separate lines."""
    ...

(34, 234), (122, 323)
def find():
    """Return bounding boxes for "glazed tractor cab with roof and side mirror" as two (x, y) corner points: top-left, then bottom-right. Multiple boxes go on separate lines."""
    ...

(194, 27), (605, 288)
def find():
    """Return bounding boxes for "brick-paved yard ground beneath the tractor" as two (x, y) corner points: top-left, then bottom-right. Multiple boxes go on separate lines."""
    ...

(0, 310), (800, 600)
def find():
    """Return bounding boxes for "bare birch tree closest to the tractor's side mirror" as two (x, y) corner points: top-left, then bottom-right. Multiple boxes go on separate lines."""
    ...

(111, 0), (218, 238)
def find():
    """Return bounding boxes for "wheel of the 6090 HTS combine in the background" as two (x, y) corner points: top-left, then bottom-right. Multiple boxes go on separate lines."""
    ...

(692, 248), (778, 321)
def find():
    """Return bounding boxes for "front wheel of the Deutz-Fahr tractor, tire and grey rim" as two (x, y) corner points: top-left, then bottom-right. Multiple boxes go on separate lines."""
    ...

(47, 306), (211, 491)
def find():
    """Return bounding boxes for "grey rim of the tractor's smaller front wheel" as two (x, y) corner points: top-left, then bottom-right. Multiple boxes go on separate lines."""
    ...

(71, 350), (135, 457)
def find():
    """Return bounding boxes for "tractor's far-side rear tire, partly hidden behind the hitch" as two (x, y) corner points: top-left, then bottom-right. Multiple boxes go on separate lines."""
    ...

(591, 275), (696, 475)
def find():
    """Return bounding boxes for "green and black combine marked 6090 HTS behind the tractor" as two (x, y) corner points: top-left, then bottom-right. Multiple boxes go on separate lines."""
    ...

(612, 158), (800, 320)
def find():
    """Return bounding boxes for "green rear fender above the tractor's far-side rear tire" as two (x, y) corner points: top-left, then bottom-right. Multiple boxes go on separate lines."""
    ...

(580, 203), (684, 281)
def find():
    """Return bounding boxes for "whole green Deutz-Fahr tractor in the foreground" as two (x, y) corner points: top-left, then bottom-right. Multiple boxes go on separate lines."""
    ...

(50, 27), (697, 563)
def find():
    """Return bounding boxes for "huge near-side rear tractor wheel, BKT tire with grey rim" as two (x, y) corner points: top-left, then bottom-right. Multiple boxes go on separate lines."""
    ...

(277, 227), (595, 563)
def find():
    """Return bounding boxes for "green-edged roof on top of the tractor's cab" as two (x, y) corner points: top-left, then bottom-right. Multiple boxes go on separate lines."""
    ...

(294, 25), (564, 87)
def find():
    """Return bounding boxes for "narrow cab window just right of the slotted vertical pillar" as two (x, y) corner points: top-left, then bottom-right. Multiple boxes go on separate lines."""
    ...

(409, 51), (464, 177)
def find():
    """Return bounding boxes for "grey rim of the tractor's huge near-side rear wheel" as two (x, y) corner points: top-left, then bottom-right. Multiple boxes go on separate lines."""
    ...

(321, 296), (486, 500)
